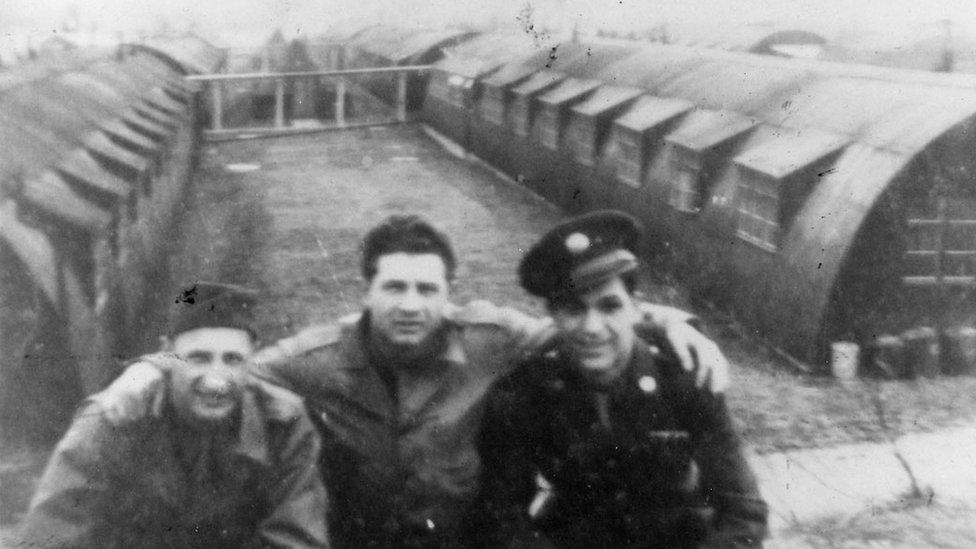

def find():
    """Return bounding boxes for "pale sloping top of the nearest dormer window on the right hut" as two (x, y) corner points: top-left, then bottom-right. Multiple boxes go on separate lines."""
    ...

(732, 127), (848, 179)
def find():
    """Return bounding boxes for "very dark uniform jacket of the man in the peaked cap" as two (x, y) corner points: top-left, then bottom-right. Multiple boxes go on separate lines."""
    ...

(480, 341), (767, 548)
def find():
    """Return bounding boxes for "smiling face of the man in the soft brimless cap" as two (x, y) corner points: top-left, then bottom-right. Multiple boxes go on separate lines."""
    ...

(167, 327), (254, 427)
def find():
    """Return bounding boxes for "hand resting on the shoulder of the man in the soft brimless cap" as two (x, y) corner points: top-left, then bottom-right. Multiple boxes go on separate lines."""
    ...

(91, 353), (181, 426)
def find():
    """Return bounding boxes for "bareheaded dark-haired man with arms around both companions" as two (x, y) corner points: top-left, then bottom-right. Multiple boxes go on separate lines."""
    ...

(107, 216), (726, 547)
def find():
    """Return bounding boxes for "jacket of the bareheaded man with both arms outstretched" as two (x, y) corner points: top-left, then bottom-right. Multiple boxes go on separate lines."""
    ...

(248, 302), (550, 548)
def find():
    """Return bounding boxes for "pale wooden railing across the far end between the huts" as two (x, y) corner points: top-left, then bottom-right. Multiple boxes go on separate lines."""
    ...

(186, 65), (430, 135)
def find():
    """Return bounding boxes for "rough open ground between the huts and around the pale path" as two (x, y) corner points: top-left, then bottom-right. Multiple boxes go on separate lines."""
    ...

(7, 126), (976, 547)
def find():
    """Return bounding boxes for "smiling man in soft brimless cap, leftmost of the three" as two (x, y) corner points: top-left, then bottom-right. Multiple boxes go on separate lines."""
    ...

(21, 282), (328, 548)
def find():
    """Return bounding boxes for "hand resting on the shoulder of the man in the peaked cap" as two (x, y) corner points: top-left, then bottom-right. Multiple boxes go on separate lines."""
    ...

(639, 303), (729, 393)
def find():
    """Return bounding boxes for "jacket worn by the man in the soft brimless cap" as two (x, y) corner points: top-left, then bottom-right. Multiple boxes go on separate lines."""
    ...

(19, 379), (328, 549)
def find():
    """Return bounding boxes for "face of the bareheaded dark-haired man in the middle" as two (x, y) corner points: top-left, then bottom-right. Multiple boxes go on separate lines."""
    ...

(363, 252), (449, 350)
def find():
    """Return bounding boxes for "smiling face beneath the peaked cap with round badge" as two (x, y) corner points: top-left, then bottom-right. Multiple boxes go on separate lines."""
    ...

(550, 276), (640, 383)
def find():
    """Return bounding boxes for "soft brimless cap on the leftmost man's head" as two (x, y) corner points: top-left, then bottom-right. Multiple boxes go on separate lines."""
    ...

(168, 282), (257, 338)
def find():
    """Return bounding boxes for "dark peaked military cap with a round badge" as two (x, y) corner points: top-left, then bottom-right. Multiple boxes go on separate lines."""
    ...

(519, 210), (641, 299)
